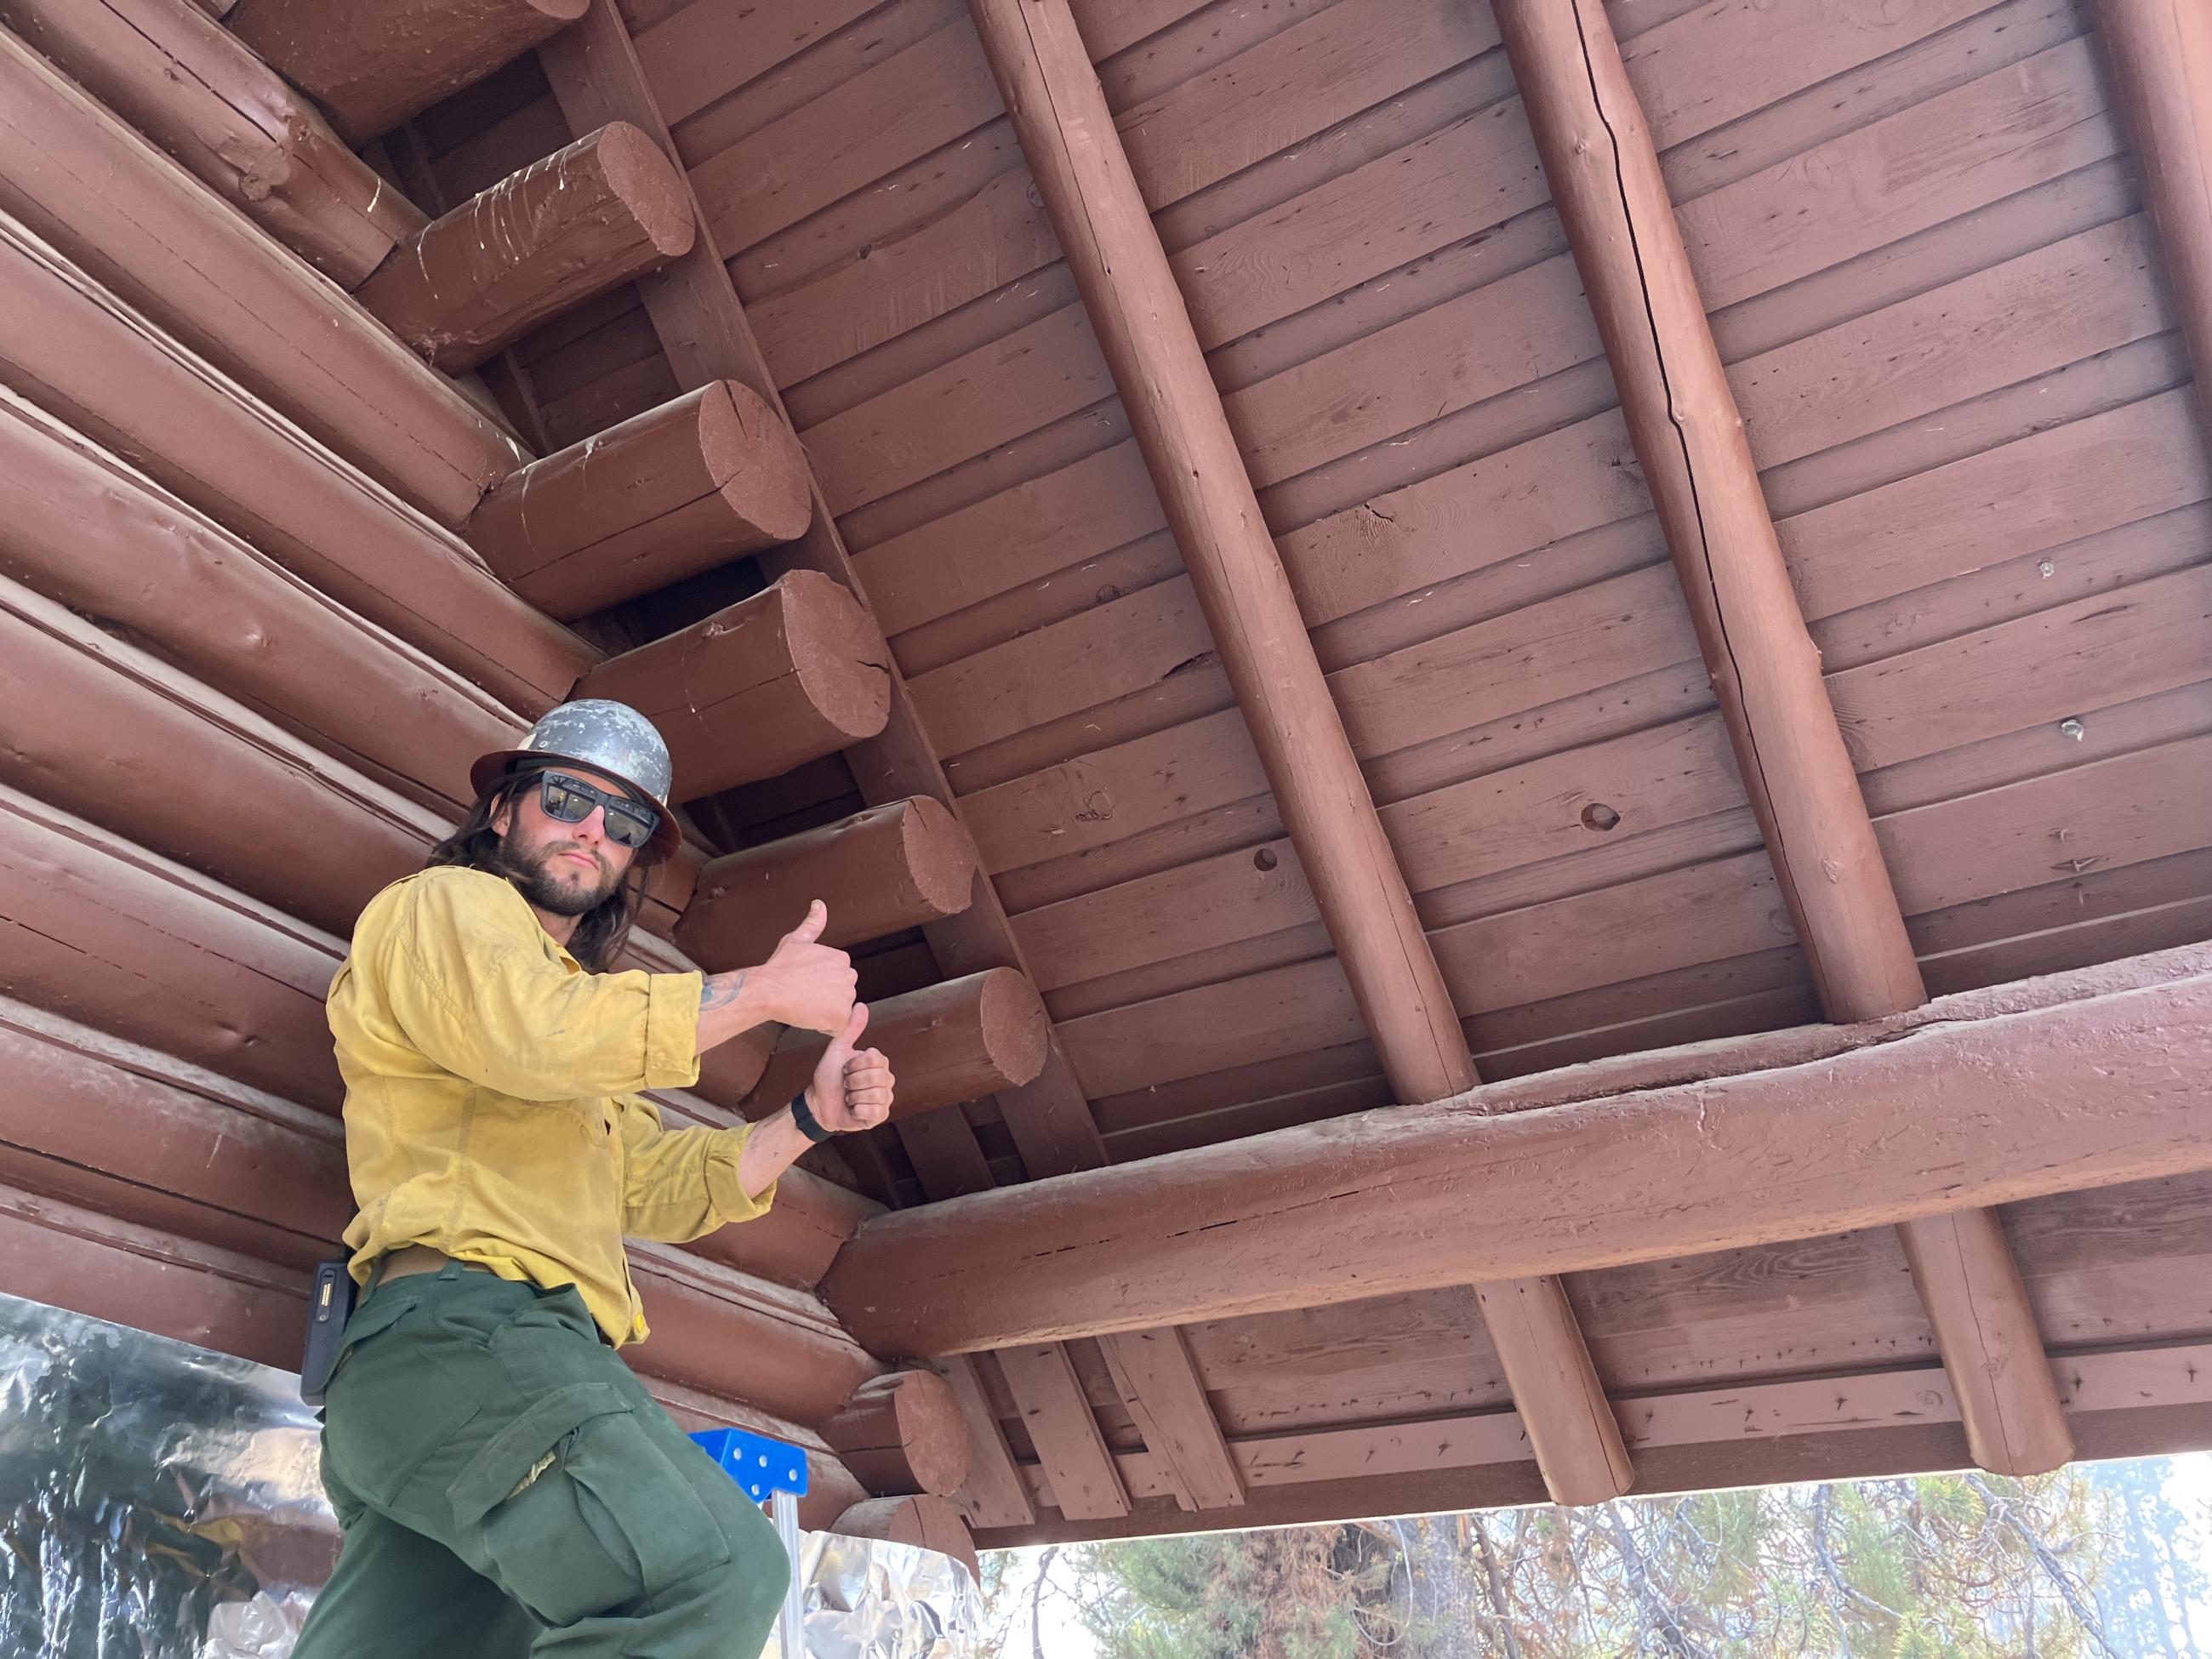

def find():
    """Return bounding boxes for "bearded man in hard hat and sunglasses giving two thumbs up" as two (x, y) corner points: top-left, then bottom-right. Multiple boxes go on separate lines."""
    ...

(296, 701), (892, 1659)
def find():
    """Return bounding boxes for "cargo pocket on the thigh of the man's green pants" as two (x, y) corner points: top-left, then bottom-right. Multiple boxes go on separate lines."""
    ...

(451, 1382), (730, 1626)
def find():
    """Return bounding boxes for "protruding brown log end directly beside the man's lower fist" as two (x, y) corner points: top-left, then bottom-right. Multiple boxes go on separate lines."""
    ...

(745, 969), (1051, 1121)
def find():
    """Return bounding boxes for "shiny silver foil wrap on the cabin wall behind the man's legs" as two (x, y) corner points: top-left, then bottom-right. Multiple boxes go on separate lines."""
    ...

(0, 1294), (980, 1659)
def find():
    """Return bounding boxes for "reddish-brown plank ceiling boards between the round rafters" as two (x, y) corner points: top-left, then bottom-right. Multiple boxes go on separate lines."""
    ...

(345, 0), (2212, 1542)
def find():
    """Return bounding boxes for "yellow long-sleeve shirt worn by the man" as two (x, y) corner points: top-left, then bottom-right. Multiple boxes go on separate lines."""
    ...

(329, 869), (774, 1345)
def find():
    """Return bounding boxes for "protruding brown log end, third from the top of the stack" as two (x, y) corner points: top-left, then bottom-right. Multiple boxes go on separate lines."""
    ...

(462, 380), (814, 619)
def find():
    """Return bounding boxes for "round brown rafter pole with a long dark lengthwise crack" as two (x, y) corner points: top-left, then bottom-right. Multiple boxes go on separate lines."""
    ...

(1496, 0), (2072, 1474)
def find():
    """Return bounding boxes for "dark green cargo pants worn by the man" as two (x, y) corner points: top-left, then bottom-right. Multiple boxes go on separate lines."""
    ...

(294, 1268), (790, 1659)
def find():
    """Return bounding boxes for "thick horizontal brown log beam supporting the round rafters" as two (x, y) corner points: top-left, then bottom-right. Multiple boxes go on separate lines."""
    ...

(823, 947), (2212, 1356)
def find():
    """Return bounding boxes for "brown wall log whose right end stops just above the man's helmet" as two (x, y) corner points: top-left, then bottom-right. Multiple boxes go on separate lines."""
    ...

(0, 208), (597, 716)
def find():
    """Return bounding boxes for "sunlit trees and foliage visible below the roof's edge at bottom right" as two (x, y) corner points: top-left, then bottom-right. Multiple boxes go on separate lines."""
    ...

(1004, 1460), (2212, 1659)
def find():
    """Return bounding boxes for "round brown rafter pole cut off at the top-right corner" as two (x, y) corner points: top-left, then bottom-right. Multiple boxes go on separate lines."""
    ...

(2095, 0), (2212, 442)
